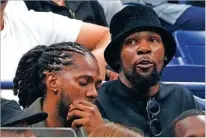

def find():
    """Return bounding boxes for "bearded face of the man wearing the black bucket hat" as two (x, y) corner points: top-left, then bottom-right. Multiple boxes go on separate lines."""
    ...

(120, 31), (164, 89)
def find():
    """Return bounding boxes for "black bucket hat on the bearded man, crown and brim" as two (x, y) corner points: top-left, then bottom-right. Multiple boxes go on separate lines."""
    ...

(104, 4), (176, 72)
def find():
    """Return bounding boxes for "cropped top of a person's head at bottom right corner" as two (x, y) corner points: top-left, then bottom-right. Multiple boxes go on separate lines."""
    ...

(175, 115), (205, 137)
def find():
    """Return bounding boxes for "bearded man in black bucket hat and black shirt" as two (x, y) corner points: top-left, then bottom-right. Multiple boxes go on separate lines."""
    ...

(96, 5), (199, 137)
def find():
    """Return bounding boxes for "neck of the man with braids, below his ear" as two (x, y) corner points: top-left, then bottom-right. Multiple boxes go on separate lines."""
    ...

(43, 97), (63, 127)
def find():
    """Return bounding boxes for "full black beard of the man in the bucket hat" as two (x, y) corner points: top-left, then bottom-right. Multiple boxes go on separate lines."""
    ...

(123, 64), (161, 95)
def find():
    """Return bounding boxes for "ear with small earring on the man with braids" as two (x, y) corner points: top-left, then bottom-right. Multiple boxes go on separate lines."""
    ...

(46, 72), (59, 95)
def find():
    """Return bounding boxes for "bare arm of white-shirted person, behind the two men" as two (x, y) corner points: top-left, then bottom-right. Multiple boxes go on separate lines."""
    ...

(76, 23), (110, 80)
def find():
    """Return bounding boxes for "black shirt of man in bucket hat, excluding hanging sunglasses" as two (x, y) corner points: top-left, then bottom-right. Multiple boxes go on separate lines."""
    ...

(96, 80), (200, 137)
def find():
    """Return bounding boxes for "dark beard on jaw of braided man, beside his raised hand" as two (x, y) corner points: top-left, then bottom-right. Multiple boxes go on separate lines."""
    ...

(57, 90), (73, 127)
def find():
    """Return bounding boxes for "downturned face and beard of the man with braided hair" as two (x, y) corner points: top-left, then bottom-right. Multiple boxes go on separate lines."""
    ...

(53, 54), (101, 126)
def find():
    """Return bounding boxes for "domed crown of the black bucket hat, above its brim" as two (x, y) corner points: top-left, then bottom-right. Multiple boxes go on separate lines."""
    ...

(110, 4), (161, 39)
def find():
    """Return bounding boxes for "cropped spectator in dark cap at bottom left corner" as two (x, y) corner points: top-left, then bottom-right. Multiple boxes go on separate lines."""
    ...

(0, 98), (47, 137)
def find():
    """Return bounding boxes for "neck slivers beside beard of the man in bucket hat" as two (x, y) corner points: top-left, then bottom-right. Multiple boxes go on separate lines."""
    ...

(119, 72), (160, 97)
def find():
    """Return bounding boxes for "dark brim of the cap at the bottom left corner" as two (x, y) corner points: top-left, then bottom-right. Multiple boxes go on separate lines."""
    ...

(1, 108), (48, 127)
